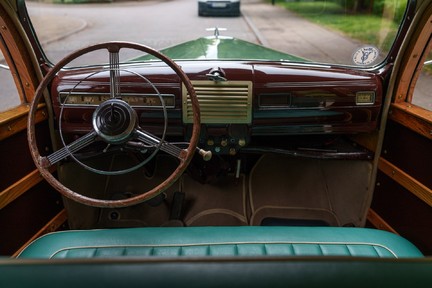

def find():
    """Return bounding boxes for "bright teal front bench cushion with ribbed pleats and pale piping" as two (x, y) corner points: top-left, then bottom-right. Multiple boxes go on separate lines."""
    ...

(18, 226), (422, 258)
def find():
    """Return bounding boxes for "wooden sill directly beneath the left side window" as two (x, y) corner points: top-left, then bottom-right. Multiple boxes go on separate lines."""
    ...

(0, 104), (48, 141)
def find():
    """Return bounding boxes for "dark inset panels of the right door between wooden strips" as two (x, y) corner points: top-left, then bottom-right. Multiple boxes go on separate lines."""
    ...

(371, 121), (432, 255)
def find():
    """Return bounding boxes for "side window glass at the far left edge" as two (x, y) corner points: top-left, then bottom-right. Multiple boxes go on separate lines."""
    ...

(0, 50), (21, 113)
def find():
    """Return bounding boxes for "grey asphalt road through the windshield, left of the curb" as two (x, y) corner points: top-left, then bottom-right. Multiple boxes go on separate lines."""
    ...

(28, 0), (258, 62)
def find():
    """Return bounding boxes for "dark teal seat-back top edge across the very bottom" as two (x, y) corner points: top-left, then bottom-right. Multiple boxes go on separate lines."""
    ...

(0, 257), (432, 288)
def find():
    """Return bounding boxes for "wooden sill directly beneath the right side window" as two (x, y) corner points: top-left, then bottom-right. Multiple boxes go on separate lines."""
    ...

(389, 102), (432, 140)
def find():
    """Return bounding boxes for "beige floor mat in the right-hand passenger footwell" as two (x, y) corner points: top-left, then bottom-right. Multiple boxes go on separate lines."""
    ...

(249, 154), (371, 226)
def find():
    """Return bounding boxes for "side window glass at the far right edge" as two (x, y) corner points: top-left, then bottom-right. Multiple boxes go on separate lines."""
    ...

(411, 49), (432, 111)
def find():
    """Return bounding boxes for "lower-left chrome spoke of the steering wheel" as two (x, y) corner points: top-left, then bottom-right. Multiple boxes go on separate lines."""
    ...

(41, 131), (97, 168)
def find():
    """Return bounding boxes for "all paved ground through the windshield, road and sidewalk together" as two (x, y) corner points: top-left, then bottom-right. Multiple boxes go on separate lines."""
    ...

(28, 0), (363, 64)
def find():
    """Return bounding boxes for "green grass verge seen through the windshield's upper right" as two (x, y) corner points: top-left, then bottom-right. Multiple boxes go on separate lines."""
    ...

(276, 0), (404, 51)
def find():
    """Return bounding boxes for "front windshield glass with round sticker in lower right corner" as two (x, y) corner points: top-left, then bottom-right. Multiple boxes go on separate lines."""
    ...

(26, 0), (407, 67)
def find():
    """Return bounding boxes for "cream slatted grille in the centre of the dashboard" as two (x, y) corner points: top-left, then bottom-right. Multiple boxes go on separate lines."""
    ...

(182, 81), (252, 124)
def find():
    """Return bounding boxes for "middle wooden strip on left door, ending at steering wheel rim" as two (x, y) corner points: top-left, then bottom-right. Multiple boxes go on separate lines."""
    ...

(0, 166), (55, 209)
